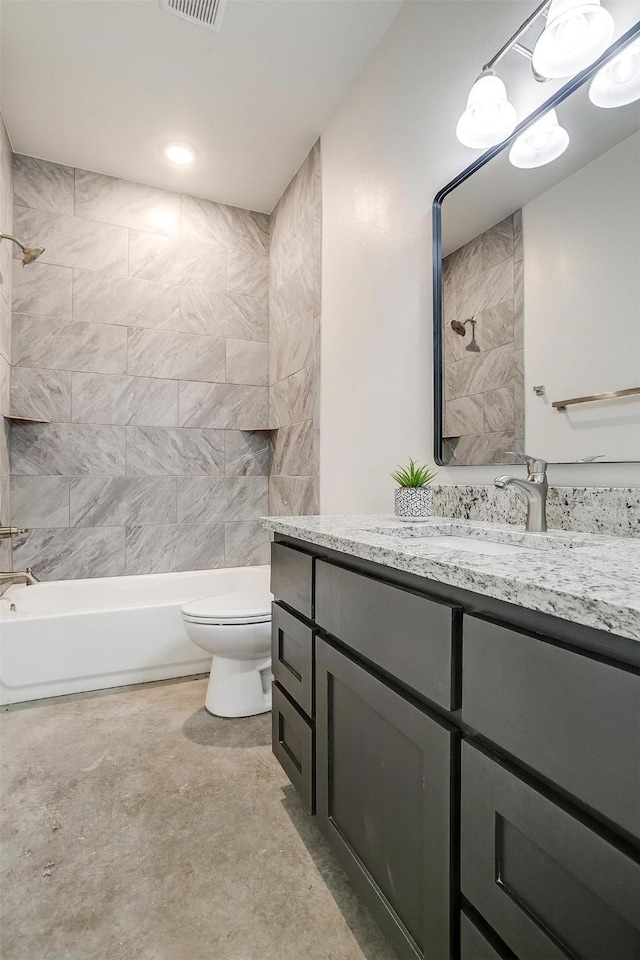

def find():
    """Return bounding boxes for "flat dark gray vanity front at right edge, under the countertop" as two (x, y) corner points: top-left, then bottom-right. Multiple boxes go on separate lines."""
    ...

(462, 617), (640, 836)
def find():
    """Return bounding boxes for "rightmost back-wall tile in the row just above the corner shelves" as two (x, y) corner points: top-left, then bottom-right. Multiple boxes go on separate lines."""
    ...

(179, 381), (269, 430)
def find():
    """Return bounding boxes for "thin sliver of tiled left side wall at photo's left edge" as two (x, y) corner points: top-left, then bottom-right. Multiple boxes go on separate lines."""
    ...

(0, 114), (13, 570)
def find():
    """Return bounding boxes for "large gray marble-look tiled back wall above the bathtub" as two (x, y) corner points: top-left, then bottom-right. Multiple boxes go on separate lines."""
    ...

(7, 156), (269, 579)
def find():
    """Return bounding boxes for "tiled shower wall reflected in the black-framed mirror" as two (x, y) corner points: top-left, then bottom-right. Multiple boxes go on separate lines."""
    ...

(443, 210), (524, 466)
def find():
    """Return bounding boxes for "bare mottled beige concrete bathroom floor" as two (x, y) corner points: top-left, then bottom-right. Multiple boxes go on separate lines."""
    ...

(0, 679), (393, 960)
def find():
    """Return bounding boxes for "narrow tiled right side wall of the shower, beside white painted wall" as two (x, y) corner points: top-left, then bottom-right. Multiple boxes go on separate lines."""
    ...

(269, 141), (322, 515)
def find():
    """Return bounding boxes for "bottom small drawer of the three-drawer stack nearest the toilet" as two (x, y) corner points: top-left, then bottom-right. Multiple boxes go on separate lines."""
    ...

(271, 683), (315, 813)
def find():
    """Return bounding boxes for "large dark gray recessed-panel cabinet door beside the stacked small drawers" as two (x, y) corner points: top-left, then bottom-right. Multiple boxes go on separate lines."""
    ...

(316, 639), (458, 960)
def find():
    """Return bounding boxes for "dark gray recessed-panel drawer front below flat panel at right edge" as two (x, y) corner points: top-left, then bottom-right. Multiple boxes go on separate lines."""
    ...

(461, 743), (640, 960)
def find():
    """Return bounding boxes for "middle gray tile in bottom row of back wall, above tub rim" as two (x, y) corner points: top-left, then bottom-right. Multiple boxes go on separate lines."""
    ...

(126, 523), (225, 574)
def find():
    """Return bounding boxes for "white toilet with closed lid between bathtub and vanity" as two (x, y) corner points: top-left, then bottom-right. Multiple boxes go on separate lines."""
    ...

(181, 591), (273, 717)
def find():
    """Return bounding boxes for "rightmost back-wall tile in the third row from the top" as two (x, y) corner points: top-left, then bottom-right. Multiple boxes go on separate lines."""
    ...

(180, 287), (269, 343)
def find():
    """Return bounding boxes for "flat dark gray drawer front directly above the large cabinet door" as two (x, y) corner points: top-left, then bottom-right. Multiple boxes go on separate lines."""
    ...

(316, 561), (458, 710)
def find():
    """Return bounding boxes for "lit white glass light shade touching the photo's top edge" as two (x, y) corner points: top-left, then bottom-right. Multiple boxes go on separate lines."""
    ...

(532, 0), (614, 78)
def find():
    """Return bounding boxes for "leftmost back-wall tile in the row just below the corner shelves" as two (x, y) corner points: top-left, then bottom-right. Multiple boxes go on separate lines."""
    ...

(11, 423), (125, 477)
